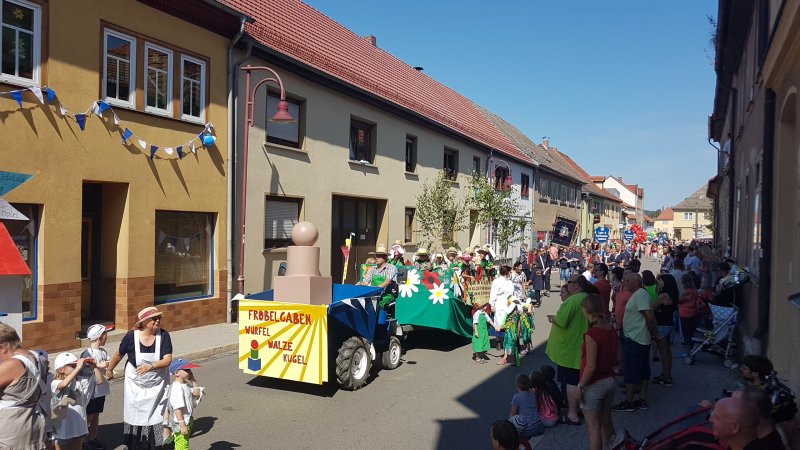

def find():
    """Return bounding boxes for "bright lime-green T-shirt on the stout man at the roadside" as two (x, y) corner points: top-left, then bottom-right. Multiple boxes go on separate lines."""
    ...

(545, 292), (589, 369)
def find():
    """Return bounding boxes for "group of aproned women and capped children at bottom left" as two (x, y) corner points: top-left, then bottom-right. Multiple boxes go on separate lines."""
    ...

(0, 307), (204, 450)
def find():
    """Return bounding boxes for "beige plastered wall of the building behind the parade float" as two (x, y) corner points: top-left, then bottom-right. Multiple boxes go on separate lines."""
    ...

(236, 52), (506, 292)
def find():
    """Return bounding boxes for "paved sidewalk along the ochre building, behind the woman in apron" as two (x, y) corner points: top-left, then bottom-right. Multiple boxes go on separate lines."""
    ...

(49, 323), (239, 376)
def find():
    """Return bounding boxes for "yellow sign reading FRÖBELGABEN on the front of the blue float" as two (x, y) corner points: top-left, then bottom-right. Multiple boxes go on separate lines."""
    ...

(239, 300), (328, 384)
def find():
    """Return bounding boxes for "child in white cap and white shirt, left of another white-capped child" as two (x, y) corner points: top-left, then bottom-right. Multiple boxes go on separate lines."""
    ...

(51, 352), (105, 450)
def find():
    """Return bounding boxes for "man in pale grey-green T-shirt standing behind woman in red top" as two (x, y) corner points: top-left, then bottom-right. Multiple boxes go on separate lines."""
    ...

(612, 273), (658, 411)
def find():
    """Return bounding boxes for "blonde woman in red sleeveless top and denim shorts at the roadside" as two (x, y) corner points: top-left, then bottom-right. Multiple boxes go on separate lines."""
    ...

(578, 294), (617, 450)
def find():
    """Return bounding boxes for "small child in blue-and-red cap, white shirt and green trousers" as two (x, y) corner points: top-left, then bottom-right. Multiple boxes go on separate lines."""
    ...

(167, 358), (203, 450)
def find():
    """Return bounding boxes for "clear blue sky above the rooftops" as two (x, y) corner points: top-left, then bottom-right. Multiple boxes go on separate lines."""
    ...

(306, 0), (717, 209)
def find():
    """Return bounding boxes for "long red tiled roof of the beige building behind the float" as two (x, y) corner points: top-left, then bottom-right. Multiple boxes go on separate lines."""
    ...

(224, 0), (530, 162)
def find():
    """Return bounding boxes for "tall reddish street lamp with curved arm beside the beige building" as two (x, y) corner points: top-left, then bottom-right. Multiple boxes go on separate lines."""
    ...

(237, 64), (295, 295)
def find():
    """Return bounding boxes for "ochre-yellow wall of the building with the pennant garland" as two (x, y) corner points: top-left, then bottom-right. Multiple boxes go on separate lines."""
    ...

(0, 0), (229, 350)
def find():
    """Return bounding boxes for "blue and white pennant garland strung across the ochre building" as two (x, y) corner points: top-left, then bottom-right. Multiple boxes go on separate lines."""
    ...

(0, 86), (217, 159)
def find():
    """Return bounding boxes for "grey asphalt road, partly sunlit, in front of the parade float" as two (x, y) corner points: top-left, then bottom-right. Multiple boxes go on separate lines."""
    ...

(100, 256), (734, 450)
